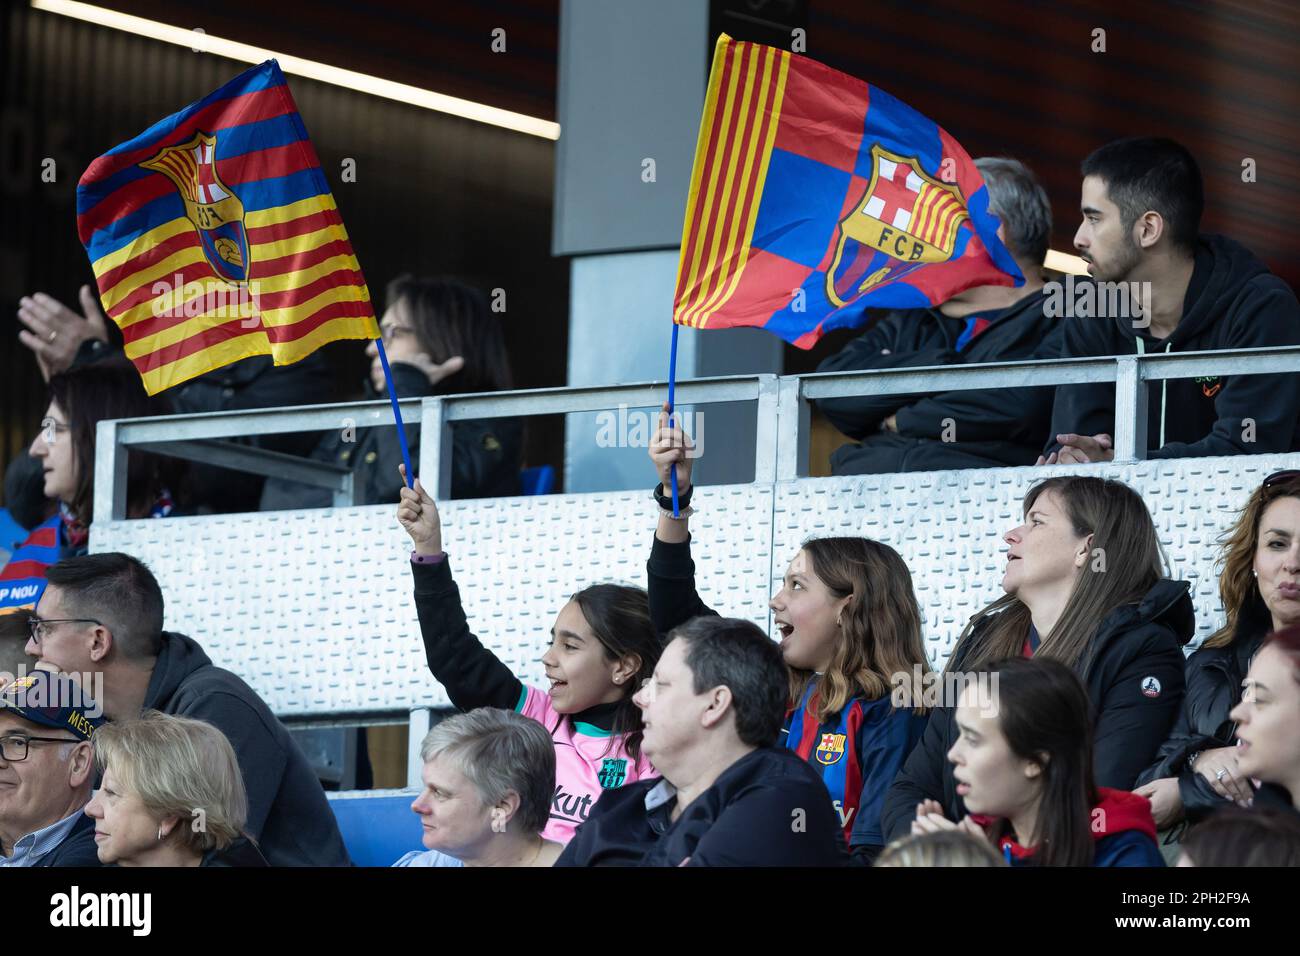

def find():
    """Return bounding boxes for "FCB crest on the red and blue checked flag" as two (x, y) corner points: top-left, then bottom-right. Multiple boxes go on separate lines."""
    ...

(826, 143), (970, 306)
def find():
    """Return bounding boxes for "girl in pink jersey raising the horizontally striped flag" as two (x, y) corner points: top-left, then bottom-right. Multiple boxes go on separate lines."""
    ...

(398, 470), (662, 843)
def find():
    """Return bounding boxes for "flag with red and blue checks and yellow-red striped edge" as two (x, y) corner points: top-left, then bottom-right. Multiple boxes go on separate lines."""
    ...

(673, 34), (1024, 349)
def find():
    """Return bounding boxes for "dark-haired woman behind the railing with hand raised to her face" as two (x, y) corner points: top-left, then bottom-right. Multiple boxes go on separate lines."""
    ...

(261, 276), (524, 511)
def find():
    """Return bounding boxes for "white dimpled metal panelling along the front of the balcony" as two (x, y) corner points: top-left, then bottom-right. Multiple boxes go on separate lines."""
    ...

(92, 454), (1300, 717)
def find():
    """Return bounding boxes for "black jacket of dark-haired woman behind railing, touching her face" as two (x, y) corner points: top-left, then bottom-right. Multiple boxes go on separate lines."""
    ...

(261, 362), (524, 511)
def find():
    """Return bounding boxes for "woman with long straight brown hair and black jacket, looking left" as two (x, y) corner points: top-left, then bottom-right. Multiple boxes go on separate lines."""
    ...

(883, 476), (1195, 839)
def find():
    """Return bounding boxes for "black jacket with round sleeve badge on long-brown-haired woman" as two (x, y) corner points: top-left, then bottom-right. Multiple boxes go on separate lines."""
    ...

(880, 579), (1196, 842)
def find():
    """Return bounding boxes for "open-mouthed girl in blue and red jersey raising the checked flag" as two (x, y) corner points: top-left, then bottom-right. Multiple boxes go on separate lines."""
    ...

(647, 406), (930, 864)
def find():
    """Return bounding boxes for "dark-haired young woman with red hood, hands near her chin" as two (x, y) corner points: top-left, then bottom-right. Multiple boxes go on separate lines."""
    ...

(911, 657), (1165, 866)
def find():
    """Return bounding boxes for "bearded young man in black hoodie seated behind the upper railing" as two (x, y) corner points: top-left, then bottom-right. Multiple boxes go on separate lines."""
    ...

(1040, 137), (1300, 464)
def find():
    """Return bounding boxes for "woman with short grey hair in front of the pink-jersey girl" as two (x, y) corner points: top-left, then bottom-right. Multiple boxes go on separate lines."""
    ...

(393, 708), (563, 866)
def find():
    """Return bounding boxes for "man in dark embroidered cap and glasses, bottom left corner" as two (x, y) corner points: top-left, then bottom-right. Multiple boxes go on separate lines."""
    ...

(0, 670), (104, 866)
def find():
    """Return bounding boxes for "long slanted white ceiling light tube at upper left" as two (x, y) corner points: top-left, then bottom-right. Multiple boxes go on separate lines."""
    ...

(31, 0), (560, 139)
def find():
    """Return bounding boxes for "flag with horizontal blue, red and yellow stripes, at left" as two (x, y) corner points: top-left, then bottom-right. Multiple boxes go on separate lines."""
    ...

(77, 60), (378, 395)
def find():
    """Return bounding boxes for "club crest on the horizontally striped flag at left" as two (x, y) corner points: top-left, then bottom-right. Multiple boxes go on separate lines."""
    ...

(140, 133), (248, 282)
